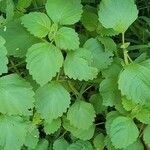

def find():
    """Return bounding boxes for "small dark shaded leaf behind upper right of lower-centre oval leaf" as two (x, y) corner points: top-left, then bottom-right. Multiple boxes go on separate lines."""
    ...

(89, 94), (105, 114)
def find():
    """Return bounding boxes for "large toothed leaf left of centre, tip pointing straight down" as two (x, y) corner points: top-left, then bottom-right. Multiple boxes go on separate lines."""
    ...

(26, 43), (63, 86)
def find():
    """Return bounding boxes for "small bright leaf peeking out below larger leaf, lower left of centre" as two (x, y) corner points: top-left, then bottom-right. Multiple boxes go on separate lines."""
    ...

(44, 118), (61, 134)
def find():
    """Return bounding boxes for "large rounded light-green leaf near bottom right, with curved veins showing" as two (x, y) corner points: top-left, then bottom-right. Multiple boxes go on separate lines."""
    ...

(110, 116), (139, 148)
